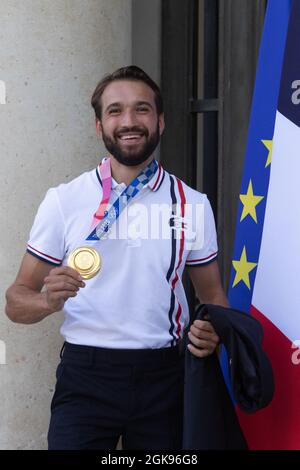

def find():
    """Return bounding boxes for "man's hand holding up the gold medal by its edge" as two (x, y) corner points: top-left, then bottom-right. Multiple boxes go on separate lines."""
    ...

(44, 266), (85, 312)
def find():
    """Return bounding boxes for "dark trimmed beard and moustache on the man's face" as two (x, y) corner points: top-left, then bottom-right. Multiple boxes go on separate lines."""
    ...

(102, 122), (160, 166)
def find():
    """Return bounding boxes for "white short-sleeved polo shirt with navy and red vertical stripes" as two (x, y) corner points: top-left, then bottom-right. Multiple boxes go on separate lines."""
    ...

(27, 160), (217, 349)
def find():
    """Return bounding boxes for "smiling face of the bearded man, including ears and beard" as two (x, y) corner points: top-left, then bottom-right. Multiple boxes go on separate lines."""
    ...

(97, 80), (164, 166)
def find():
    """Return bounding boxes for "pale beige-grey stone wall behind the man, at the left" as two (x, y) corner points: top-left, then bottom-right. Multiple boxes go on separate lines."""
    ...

(0, 0), (132, 449)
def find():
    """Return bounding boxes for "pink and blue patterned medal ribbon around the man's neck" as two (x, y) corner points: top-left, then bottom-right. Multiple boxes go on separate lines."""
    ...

(86, 158), (158, 240)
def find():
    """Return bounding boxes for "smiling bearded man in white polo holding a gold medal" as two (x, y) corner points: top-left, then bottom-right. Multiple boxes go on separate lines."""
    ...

(6, 66), (227, 449)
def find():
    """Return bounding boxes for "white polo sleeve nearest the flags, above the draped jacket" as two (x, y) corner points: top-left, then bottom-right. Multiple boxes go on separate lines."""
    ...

(186, 195), (218, 266)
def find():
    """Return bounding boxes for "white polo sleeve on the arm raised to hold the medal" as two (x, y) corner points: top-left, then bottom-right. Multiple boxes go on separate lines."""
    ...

(27, 188), (65, 266)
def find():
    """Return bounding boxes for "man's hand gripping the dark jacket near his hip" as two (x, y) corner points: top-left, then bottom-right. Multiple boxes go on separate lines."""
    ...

(188, 320), (220, 357)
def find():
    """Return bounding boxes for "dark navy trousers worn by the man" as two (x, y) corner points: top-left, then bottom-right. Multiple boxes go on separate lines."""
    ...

(48, 343), (184, 450)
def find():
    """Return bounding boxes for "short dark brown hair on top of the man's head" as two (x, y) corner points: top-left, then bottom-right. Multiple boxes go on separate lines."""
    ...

(91, 65), (163, 120)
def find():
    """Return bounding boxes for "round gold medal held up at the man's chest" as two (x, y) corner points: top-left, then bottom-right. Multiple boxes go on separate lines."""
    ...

(68, 246), (102, 279)
